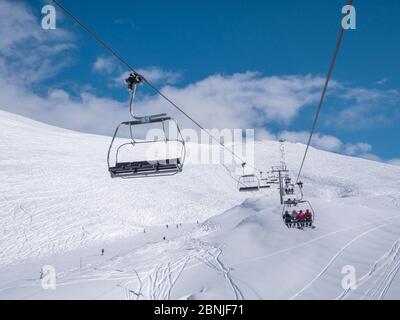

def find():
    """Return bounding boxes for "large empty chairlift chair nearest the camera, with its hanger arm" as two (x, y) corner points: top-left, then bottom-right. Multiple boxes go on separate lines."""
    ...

(107, 73), (186, 178)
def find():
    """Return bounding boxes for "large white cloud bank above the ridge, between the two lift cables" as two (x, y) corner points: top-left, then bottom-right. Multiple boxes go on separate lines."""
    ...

(133, 72), (323, 129)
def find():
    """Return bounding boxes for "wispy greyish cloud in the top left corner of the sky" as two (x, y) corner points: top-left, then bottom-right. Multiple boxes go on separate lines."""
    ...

(0, 0), (75, 86)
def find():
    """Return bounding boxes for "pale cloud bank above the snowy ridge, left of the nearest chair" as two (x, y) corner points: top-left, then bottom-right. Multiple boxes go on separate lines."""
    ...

(0, 80), (128, 134)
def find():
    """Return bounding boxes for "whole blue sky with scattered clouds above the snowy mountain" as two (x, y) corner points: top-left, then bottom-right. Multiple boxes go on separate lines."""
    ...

(0, 0), (400, 162)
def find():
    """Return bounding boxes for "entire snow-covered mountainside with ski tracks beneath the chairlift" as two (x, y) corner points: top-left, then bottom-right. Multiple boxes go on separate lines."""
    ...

(0, 111), (400, 300)
